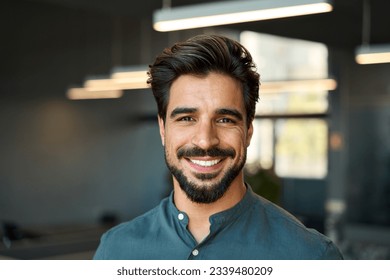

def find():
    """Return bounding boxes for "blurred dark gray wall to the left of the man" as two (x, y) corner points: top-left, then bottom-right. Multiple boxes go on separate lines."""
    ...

(0, 1), (168, 226)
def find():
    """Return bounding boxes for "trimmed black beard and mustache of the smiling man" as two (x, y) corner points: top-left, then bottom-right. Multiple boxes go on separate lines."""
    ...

(165, 148), (246, 204)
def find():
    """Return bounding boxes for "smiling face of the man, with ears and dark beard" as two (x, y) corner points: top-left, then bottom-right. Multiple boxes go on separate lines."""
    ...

(159, 73), (253, 203)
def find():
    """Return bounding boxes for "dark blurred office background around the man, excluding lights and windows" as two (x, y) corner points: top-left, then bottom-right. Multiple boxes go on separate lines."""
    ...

(0, 0), (390, 259)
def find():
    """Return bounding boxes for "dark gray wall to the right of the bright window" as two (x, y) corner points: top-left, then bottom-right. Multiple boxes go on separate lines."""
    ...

(329, 50), (390, 226)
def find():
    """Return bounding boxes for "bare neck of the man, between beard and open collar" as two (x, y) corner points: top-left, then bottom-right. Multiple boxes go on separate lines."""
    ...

(174, 176), (246, 242)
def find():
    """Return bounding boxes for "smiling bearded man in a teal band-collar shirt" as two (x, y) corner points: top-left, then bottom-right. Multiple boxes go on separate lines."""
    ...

(94, 35), (342, 260)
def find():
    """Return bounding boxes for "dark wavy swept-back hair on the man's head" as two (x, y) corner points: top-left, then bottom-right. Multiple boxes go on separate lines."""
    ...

(148, 35), (260, 125)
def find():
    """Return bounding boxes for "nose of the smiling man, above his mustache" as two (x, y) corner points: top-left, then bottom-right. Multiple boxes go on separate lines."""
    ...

(192, 120), (219, 150)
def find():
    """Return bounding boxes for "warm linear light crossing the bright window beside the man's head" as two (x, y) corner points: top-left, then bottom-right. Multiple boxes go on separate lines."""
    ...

(260, 79), (337, 93)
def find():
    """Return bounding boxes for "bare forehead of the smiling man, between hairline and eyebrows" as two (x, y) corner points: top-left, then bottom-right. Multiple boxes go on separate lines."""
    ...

(168, 72), (245, 112)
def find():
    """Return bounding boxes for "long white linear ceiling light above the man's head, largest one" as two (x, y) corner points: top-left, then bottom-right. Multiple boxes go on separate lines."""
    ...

(153, 0), (333, 32)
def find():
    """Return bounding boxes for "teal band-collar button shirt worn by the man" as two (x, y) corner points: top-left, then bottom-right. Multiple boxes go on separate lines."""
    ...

(94, 187), (343, 260)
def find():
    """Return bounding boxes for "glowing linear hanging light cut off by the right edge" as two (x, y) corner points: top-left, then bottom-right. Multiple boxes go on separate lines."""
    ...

(355, 45), (390, 64)
